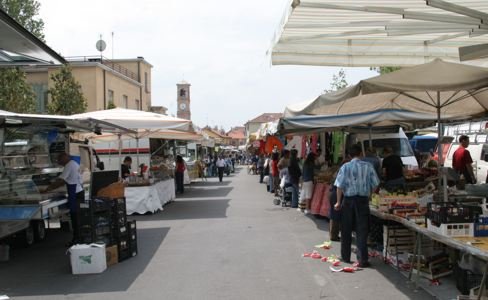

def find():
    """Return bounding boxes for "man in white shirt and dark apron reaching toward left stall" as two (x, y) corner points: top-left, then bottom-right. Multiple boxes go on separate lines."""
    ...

(44, 153), (85, 244)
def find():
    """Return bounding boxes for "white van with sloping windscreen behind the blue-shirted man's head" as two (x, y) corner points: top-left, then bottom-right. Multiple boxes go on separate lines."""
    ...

(348, 128), (418, 168)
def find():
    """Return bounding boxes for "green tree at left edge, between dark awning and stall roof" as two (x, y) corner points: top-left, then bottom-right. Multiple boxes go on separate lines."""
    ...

(0, 68), (36, 113)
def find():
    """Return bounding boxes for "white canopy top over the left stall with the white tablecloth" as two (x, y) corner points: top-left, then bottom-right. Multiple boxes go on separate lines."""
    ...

(72, 108), (191, 131)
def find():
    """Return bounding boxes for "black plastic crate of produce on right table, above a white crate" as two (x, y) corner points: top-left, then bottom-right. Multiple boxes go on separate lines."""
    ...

(425, 202), (482, 225)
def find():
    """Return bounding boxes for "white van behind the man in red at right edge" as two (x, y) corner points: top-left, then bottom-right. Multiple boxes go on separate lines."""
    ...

(444, 134), (488, 183)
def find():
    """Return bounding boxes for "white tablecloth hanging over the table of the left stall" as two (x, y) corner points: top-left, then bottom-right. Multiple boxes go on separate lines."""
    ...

(125, 179), (176, 215)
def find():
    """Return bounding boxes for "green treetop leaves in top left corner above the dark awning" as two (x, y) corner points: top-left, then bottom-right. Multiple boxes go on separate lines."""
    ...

(0, 0), (44, 42)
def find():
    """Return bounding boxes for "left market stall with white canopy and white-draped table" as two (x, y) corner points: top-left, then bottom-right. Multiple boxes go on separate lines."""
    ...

(70, 109), (198, 214)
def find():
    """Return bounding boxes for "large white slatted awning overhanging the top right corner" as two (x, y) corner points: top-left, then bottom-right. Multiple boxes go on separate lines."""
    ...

(271, 0), (488, 67)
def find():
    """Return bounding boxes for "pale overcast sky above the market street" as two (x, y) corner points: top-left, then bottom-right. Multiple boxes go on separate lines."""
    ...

(38, 0), (377, 129)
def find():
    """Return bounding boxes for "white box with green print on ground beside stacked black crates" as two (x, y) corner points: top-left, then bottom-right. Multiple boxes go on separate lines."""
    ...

(68, 244), (107, 274)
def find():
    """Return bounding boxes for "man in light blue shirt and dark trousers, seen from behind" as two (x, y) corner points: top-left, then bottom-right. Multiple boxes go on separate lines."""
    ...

(334, 144), (380, 268)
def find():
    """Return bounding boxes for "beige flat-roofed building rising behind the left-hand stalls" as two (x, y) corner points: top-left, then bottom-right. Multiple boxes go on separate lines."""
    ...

(25, 57), (152, 113)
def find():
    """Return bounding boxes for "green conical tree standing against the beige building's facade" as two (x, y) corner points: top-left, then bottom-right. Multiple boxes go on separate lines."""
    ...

(47, 65), (87, 115)
